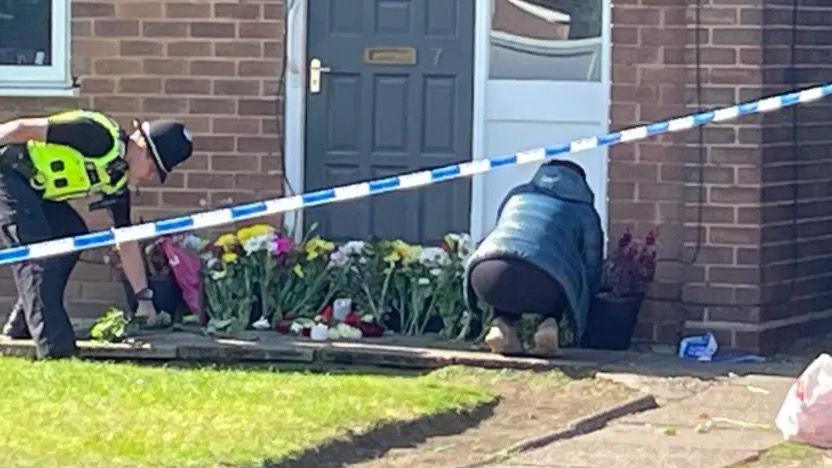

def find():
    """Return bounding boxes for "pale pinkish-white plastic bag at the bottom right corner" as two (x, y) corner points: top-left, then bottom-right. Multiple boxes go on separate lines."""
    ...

(777, 354), (832, 448)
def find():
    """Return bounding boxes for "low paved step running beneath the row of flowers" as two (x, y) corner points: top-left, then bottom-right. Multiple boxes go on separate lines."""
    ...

(0, 328), (622, 370)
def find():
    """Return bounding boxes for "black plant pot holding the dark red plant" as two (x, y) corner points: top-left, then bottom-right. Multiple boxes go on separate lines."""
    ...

(585, 293), (644, 351)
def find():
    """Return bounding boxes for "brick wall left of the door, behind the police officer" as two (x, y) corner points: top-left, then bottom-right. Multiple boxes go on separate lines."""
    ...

(0, 0), (283, 317)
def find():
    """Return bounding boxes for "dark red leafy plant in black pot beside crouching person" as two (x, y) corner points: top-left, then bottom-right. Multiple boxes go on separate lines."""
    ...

(586, 229), (658, 350)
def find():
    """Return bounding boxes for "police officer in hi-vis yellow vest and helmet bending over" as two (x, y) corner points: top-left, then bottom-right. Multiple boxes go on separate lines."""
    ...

(0, 110), (193, 358)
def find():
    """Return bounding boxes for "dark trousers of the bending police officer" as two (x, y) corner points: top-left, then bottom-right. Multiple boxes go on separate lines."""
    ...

(0, 167), (87, 357)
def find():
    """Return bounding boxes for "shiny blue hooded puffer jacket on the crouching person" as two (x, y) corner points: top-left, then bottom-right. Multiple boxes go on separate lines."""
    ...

(464, 164), (604, 341)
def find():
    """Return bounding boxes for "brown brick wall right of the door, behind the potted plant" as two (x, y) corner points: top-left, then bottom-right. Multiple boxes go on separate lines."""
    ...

(609, 0), (832, 352)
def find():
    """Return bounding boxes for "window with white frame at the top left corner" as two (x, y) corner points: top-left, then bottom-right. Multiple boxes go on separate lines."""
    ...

(0, 0), (72, 95)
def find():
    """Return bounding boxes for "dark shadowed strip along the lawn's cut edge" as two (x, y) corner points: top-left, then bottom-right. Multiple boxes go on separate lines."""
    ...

(264, 398), (500, 468)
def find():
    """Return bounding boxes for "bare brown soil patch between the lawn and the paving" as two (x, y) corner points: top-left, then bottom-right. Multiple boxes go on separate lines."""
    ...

(281, 369), (637, 468)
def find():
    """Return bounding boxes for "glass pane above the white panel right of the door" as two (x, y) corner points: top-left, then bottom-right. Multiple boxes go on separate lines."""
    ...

(489, 0), (603, 81)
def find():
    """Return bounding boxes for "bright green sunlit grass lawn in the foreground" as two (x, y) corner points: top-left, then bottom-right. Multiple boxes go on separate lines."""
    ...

(0, 357), (494, 467)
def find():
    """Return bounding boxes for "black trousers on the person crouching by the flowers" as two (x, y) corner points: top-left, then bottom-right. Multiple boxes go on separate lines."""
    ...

(470, 258), (566, 321)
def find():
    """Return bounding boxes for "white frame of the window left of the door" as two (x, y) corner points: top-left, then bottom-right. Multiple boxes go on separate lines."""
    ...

(0, 0), (76, 96)
